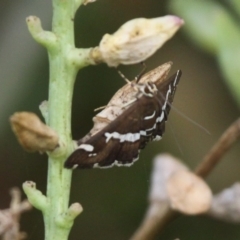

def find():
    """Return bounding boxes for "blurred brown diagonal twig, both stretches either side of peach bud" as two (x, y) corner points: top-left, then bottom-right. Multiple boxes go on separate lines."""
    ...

(131, 119), (240, 240)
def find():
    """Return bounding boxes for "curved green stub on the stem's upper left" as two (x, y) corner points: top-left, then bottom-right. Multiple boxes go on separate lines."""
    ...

(26, 16), (57, 49)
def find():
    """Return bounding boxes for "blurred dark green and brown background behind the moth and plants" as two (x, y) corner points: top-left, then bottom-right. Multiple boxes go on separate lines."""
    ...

(0, 0), (240, 240)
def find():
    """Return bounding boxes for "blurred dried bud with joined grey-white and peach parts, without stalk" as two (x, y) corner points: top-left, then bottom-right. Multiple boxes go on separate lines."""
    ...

(149, 154), (212, 214)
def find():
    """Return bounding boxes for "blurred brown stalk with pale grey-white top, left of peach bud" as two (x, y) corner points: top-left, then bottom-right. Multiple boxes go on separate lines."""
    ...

(130, 154), (187, 240)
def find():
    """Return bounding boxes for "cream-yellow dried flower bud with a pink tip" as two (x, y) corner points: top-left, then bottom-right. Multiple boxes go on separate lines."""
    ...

(96, 15), (184, 66)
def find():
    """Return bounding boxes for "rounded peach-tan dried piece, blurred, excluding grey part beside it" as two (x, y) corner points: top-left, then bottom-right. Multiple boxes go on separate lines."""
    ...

(167, 170), (212, 214)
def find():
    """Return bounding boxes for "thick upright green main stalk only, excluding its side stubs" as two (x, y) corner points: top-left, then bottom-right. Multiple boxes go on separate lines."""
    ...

(43, 0), (85, 240)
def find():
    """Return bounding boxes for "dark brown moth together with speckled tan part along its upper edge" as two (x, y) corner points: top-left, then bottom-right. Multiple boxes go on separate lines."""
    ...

(65, 63), (181, 168)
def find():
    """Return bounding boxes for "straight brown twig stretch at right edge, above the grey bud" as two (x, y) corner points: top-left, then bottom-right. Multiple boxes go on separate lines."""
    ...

(195, 119), (240, 177)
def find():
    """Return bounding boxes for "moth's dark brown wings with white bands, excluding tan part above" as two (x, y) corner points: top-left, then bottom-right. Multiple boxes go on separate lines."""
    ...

(65, 67), (181, 168)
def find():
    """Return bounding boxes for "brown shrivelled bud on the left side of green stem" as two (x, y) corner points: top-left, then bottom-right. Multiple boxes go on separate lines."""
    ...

(10, 112), (59, 152)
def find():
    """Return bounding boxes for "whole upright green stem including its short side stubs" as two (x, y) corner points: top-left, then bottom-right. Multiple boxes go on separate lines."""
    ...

(23, 0), (94, 236)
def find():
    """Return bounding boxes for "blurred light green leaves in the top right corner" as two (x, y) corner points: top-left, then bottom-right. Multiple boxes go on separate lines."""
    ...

(170, 0), (240, 106)
